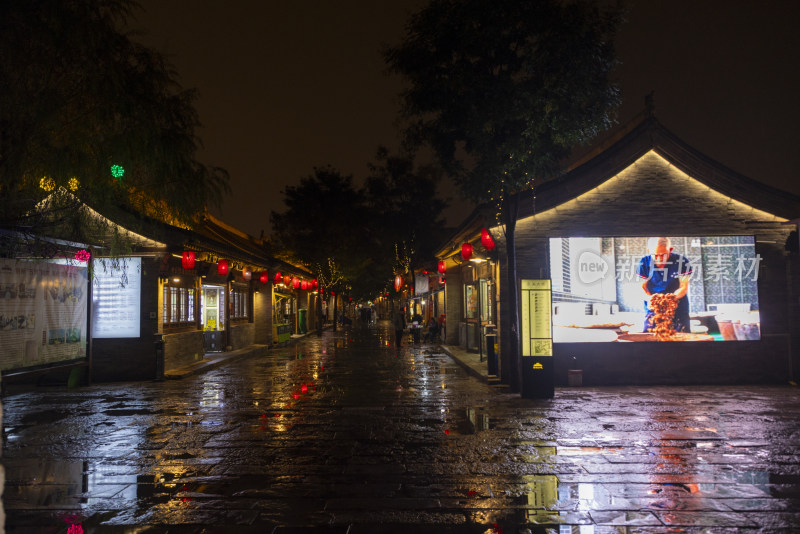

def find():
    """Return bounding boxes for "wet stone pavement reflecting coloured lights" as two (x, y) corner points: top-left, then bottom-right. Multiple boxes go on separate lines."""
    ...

(2, 323), (800, 534)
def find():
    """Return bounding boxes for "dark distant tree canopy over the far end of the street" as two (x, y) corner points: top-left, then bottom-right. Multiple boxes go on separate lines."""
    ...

(271, 148), (446, 301)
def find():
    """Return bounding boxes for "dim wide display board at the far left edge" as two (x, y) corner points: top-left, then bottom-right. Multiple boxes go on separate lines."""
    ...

(0, 259), (88, 370)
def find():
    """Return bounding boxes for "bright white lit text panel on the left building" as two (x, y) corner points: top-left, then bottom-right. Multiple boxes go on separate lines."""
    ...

(92, 258), (142, 338)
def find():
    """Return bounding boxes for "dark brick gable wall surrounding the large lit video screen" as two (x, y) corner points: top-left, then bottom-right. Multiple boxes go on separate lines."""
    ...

(496, 152), (800, 385)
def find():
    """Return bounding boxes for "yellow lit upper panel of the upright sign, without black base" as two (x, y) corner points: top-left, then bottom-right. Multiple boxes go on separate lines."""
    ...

(520, 280), (553, 356)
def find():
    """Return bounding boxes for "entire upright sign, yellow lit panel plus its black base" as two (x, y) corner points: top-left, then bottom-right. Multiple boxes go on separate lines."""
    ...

(520, 280), (555, 398)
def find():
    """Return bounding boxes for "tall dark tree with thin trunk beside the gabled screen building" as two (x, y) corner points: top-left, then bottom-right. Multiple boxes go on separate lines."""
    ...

(384, 0), (620, 392)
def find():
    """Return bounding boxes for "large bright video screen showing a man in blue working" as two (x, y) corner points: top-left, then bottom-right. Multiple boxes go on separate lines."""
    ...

(549, 236), (761, 343)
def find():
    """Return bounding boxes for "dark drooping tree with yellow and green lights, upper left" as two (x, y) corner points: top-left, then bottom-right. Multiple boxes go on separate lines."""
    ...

(0, 0), (229, 258)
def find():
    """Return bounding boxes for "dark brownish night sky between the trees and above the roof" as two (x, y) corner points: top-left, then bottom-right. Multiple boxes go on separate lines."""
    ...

(131, 0), (800, 236)
